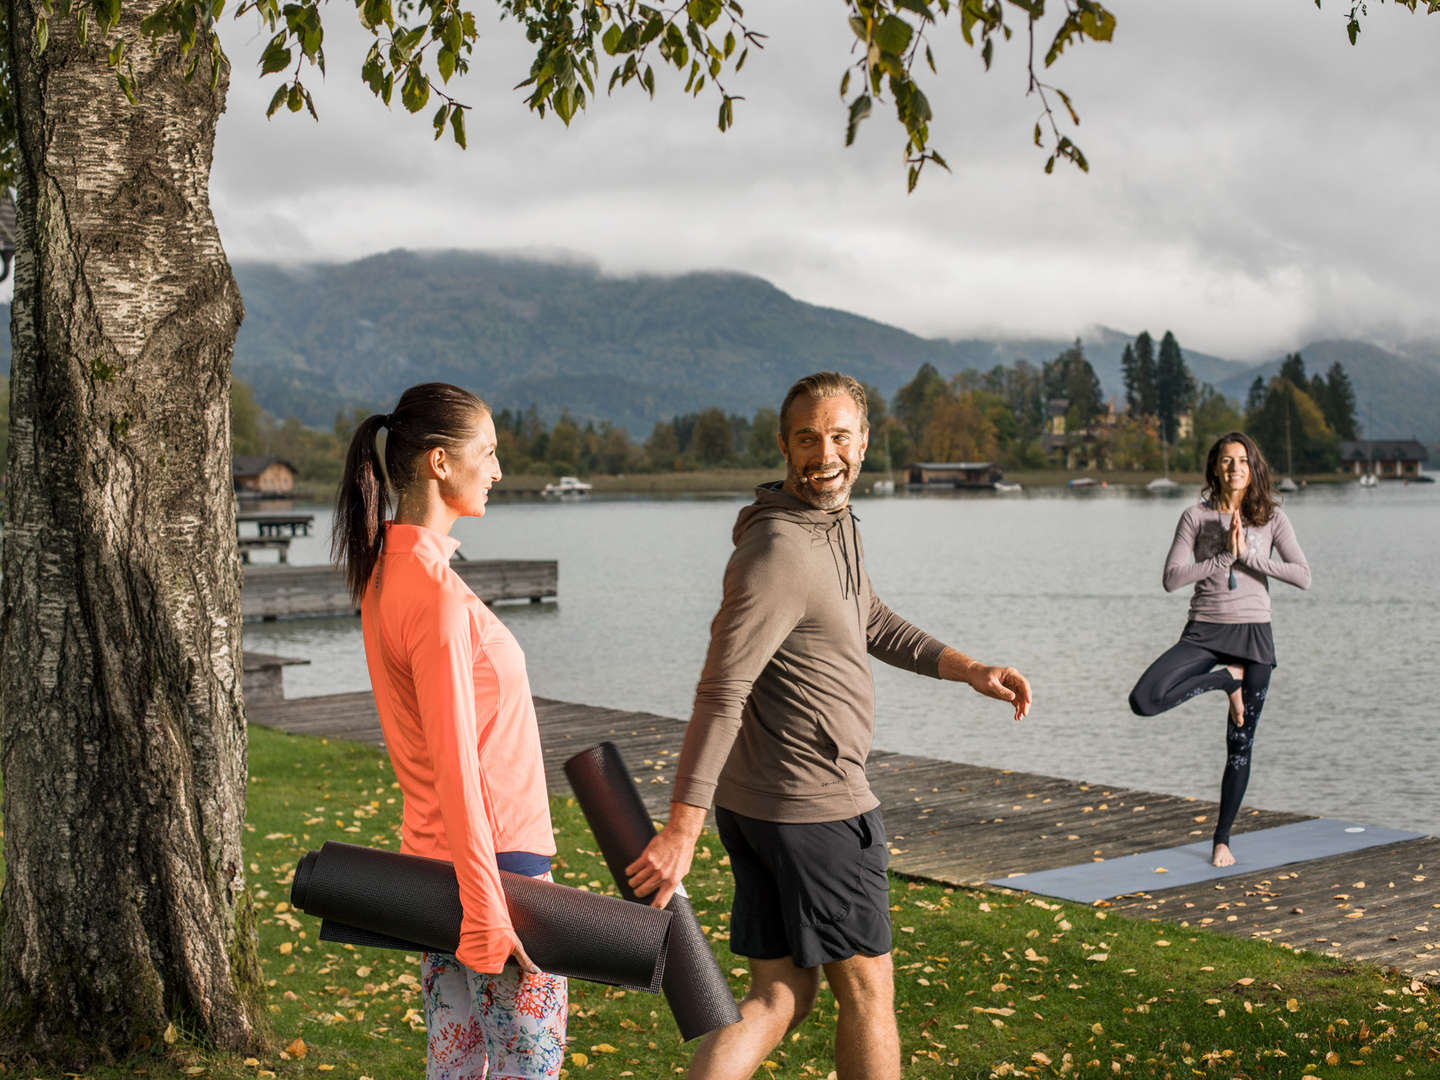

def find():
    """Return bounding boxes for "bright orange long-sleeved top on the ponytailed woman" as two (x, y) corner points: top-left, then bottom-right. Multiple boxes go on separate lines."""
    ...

(360, 523), (554, 972)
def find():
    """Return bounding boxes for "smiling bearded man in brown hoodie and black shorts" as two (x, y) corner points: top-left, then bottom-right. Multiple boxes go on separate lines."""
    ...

(628, 372), (1030, 1080)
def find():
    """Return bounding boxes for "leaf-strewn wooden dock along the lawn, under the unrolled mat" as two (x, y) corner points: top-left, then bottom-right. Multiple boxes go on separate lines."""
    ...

(248, 691), (1440, 985)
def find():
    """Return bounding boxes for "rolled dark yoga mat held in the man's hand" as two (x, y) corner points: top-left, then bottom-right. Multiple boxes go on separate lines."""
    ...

(564, 743), (740, 1041)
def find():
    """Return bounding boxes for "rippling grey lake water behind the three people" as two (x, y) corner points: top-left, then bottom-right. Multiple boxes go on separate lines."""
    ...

(245, 484), (1440, 834)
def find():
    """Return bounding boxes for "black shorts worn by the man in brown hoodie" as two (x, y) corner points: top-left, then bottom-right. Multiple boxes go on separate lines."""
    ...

(716, 806), (890, 968)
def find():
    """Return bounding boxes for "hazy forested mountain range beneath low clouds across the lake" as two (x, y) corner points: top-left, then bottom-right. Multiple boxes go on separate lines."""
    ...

(0, 251), (1440, 444)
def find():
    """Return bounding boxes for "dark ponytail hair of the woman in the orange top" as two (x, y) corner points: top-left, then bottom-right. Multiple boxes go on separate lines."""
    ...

(330, 383), (490, 606)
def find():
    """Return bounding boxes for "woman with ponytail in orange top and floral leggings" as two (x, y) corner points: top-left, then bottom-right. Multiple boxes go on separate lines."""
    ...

(333, 383), (567, 1080)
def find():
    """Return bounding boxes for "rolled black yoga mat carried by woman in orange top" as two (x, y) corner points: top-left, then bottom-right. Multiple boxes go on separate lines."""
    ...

(289, 841), (674, 994)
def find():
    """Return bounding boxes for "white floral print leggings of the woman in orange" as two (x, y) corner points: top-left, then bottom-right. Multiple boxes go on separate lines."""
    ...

(420, 874), (569, 1080)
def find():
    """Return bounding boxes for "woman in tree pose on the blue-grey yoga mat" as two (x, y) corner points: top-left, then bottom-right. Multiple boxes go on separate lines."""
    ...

(1130, 432), (1310, 867)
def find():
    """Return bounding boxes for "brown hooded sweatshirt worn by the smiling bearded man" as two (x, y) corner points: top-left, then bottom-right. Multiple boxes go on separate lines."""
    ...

(672, 481), (945, 822)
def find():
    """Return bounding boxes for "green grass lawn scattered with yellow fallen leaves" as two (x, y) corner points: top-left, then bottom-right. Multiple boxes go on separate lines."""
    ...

(4, 727), (1440, 1080)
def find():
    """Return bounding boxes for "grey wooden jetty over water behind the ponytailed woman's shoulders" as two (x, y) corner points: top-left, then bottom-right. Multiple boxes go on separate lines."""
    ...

(240, 559), (560, 619)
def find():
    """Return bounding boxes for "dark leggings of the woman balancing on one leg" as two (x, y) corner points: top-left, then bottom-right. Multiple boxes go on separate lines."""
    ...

(1130, 641), (1270, 844)
